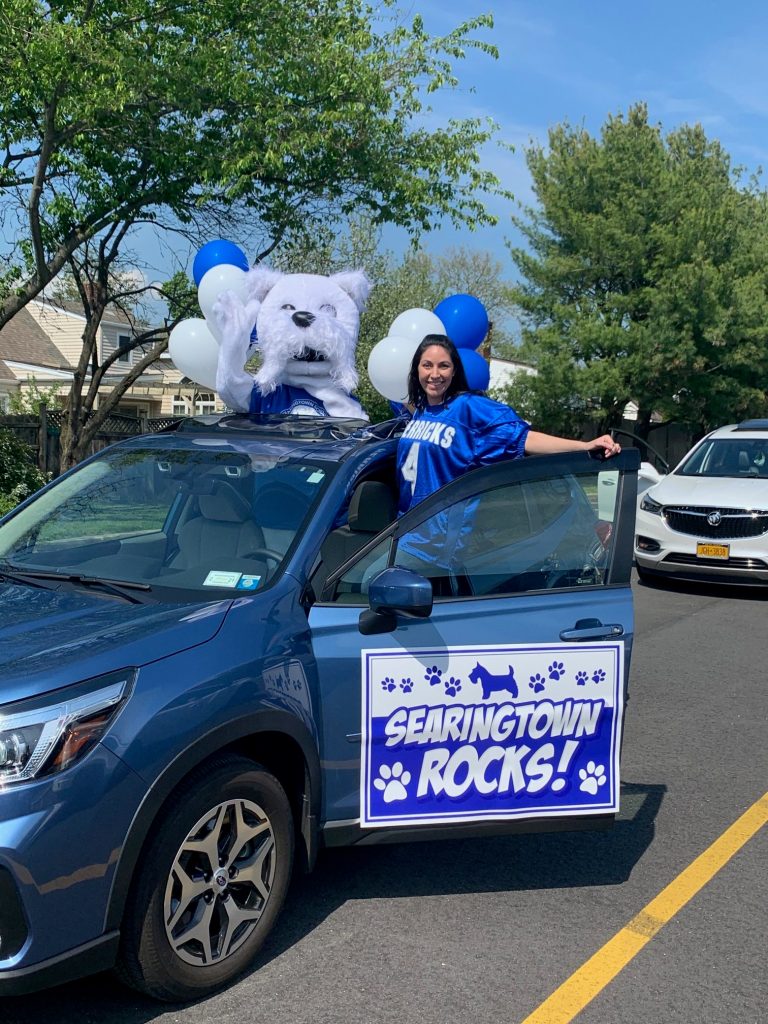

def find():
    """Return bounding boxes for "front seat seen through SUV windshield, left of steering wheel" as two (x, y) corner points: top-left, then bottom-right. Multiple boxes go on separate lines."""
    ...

(171, 483), (264, 569)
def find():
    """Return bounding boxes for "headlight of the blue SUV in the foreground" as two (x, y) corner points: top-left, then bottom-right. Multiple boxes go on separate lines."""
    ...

(0, 669), (135, 788)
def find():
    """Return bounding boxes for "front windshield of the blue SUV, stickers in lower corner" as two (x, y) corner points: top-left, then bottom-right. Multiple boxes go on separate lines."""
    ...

(0, 439), (329, 600)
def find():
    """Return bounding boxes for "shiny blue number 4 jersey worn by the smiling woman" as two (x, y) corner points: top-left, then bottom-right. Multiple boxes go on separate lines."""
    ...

(397, 393), (530, 515)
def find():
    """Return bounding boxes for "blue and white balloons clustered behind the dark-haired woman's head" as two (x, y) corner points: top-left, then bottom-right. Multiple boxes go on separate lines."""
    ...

(368, 295), (490, 402)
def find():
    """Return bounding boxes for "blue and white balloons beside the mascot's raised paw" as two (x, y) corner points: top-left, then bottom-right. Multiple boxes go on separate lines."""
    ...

(168, 239), (248, 391)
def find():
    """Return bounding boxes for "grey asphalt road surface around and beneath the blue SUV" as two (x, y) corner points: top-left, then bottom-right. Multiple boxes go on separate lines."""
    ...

(0, 583), (768, 1024)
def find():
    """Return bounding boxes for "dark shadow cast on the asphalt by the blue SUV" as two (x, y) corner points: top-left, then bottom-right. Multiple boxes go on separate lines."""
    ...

(0, 782), (667, 1024)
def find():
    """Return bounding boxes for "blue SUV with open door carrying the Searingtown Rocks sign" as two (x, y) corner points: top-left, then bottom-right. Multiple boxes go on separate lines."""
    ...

(0, 416), (639, 1000)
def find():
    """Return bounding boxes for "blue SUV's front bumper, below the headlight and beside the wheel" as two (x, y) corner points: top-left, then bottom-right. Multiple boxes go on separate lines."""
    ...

(0, 745), (145, 995)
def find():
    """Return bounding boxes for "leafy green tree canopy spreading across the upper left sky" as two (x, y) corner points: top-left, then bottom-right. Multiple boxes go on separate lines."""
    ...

(0, 0), (499, 327)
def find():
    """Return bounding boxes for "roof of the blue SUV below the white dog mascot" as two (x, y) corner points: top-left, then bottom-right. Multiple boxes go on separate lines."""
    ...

(123, 414), (406, 462)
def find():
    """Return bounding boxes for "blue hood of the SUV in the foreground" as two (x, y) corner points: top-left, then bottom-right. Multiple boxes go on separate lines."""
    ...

(0, 583), (231, 703)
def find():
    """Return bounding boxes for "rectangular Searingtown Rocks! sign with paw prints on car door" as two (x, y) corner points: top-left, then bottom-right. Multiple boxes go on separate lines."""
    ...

(360, 640), (624, 827)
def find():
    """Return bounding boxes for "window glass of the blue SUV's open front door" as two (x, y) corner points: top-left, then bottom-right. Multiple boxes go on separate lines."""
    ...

(394, 469), (618, 598)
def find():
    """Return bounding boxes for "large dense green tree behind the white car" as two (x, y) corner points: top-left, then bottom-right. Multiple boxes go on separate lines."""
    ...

(506, 104), (768, 436)
